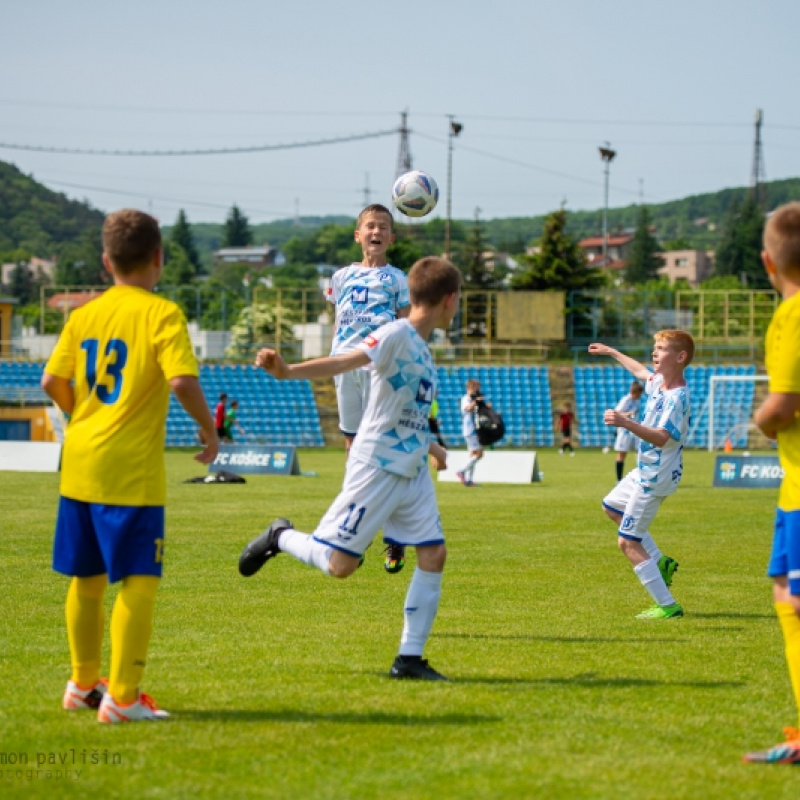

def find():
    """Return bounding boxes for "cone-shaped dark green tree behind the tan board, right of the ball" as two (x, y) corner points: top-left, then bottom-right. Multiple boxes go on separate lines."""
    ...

(511, 208), (605, 292)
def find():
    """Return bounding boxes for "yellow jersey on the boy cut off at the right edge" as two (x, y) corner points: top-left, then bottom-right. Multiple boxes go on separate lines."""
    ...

(766, 294), (800, 511)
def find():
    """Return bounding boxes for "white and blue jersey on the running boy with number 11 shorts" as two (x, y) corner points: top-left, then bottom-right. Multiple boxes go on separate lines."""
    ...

(349, 319), (436, 478)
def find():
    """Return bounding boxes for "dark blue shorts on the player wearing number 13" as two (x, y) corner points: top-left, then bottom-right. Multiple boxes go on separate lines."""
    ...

(53, 497), (164, 583)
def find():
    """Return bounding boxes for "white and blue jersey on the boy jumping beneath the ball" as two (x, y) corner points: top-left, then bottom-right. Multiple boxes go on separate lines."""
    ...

(325, 264), (410, 356)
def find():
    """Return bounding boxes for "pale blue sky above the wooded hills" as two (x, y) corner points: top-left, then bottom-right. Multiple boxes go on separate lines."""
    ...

(0, 0), (800, 228)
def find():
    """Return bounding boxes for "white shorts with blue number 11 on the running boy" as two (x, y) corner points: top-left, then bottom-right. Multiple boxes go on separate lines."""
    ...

(313, 458), (444, 556)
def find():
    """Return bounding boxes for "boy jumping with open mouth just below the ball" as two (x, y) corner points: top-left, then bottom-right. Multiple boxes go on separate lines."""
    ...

(326, 203), (411, 573)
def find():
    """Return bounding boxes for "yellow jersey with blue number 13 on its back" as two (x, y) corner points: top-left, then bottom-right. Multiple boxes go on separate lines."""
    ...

(45, 286), (197, 506)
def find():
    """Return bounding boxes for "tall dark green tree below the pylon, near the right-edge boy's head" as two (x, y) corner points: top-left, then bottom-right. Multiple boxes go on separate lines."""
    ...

(714, 195), (769, 288)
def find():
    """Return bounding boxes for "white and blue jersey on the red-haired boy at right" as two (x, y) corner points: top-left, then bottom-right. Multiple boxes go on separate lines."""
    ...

(637, 373), (691, 496)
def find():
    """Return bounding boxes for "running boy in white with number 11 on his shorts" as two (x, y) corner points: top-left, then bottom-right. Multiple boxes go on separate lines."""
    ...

(239, 257), (461, 680)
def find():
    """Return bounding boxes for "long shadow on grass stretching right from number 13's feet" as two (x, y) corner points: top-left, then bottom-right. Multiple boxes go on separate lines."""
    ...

(175, 708), (496, 727)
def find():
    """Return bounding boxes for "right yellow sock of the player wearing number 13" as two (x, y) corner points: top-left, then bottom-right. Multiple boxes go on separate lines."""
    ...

(108, 575), (160, 705)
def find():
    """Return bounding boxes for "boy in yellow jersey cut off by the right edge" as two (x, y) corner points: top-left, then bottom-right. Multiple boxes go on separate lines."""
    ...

(744, 202), (800, 764)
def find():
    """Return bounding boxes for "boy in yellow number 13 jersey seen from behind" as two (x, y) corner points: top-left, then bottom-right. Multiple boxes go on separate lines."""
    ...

(42, 209), (219, 722)
